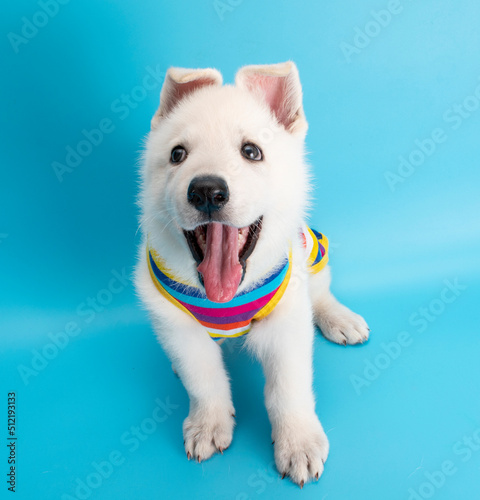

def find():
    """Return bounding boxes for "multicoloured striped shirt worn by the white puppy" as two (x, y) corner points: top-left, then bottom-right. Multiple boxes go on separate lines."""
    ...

(147, 226), (328, 340)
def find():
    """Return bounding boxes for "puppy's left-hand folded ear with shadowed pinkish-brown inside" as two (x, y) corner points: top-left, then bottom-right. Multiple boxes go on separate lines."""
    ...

(151, 68), (222, 130)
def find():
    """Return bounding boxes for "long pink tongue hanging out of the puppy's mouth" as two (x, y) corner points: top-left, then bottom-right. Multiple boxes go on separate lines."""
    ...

(198, 222), (242, 302)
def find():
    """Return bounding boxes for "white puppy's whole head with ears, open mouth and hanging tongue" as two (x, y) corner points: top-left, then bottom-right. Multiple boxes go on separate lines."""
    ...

(141, 62), (307, 302)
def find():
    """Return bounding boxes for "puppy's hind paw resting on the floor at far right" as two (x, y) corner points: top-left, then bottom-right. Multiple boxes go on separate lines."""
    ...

(315, 303), (370, 345)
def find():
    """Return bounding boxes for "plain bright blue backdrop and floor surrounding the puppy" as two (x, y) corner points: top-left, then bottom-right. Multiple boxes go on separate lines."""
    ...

(0, 0), (480, 500)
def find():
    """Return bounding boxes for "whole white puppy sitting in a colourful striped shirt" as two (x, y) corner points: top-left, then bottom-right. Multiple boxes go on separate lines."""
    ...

(136, 62), (369, 486)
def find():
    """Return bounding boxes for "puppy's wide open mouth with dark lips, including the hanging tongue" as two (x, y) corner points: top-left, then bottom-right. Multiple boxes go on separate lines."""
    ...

(184, 217), (262, 302)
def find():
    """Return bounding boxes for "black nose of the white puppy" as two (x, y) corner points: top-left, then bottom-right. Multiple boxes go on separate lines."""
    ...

(187, 175), (229, 215)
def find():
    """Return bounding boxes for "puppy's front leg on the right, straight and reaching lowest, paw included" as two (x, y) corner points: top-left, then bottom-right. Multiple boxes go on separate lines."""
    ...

(246, 280), (328, 487)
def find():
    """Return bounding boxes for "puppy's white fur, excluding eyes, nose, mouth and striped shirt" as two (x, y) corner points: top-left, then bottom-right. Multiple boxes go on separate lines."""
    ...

(136, 62), (368, 486)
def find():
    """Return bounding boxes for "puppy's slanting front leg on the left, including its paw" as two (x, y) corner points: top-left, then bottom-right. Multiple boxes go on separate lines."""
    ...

(154, 312), (235, 462)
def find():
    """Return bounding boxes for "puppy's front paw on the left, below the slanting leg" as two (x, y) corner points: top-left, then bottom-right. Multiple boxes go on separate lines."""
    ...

(183, 405), (235, 462)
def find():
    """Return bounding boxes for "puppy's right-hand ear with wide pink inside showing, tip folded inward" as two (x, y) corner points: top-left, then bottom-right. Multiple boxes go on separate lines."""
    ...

(235, 61), (308, 133)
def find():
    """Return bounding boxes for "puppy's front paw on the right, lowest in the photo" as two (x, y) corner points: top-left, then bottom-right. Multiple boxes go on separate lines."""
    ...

(273, 416), (329, 488)
